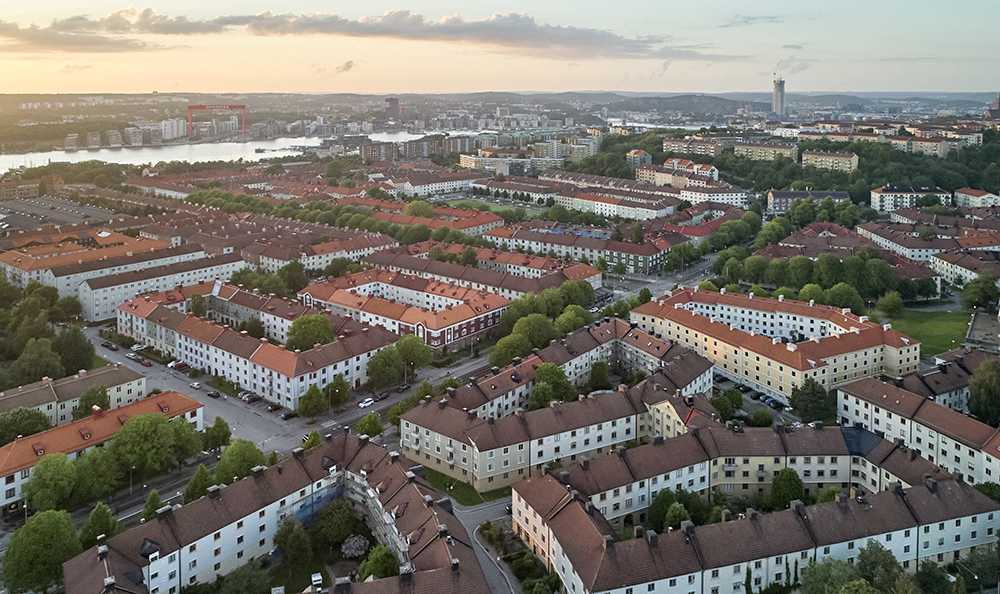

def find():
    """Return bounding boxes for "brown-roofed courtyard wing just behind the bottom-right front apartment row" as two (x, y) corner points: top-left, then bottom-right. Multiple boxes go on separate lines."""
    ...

(551, 423), (952, 528)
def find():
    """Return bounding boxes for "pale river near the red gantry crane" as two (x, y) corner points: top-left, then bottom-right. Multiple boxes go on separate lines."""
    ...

(0, 132), (432, 173)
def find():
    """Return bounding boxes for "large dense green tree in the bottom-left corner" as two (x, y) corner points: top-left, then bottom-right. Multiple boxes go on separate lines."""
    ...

(3, 510), (83, 594)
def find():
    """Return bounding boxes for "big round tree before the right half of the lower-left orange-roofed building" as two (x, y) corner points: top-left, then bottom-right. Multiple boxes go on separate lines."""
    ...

(109, 414), (180, 477)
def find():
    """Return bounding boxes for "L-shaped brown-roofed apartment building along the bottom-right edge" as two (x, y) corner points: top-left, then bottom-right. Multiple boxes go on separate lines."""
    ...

(512, 475), (1000, 594)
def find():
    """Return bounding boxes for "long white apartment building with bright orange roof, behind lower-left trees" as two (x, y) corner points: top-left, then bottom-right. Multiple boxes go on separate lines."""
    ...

(0, 391), (204, 517)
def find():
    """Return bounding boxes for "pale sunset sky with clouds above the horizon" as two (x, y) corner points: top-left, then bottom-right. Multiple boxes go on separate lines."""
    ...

(0, 0), (1000, 94)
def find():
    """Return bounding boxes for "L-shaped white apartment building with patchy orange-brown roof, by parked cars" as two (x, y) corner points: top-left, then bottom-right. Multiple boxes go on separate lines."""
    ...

(118, 299), (399, 409)
